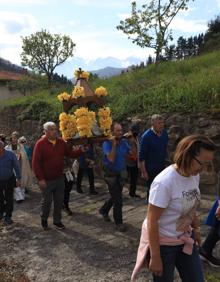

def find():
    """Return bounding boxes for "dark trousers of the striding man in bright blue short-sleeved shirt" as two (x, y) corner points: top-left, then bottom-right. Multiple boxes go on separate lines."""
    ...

(100, 175), (123, 224)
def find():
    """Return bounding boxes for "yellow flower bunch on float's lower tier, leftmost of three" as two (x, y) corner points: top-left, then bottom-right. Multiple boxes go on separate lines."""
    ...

(59, 113), (77, 140)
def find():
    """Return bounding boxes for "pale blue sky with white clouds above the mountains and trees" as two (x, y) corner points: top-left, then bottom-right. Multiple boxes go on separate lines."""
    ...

(0, 0), (220, 75)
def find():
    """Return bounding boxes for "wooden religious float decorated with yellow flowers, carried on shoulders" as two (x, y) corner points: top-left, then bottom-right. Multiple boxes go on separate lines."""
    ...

(57, 69), (112, 145)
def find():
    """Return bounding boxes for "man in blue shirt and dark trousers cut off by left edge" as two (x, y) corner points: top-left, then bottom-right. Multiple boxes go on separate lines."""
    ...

(0, 141), (21, 224)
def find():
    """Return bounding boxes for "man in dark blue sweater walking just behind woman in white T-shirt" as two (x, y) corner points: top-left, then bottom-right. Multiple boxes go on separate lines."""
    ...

(139, 114), (168, 198)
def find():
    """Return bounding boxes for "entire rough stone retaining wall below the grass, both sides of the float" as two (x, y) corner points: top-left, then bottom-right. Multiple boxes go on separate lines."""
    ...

(0, 107), (220, 194)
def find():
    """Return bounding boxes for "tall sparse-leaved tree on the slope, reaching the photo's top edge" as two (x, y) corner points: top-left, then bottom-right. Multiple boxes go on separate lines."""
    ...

(117, 0), (194, 62)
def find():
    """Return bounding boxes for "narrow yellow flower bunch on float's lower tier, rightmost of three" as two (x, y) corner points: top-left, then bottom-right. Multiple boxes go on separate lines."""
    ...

(98, 107), (112, 136)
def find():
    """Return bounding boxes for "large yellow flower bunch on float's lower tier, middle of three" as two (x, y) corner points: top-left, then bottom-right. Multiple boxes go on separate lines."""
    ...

(74, 107), (95, 137)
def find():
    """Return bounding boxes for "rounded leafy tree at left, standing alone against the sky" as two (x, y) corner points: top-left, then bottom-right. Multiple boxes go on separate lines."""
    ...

(21, 30), (75, 86)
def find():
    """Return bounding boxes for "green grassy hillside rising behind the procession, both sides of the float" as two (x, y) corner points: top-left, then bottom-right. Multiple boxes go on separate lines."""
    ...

(1, 51), (220, 120)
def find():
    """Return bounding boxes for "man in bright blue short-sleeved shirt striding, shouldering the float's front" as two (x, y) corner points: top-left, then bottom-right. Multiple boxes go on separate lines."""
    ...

(99, 123), (130, 232)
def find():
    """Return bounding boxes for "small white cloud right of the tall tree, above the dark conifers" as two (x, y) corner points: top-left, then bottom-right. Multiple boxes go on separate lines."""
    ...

(170, 17), (207, 33)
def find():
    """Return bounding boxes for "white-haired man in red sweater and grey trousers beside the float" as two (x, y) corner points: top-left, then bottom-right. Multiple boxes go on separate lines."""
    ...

(32, 122), (86, 230)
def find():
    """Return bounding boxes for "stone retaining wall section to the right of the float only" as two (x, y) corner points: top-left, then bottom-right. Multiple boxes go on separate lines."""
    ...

(128, 112), (220, 194)
